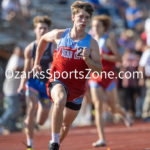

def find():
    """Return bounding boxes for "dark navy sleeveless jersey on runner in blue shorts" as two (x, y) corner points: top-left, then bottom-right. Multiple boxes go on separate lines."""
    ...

(32, 42), (53, 83)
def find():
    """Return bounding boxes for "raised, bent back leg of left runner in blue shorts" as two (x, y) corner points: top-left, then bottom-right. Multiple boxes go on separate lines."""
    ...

(36, 98), (51, 125)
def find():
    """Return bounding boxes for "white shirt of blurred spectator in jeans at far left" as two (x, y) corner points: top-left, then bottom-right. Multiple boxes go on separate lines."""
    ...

(3, 55), (24, 96)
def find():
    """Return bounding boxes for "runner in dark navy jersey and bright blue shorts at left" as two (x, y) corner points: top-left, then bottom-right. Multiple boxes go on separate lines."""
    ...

(18, 16), (53, 150)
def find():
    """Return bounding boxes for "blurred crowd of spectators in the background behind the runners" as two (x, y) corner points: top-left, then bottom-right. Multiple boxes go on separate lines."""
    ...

(0, 0), (150, 133)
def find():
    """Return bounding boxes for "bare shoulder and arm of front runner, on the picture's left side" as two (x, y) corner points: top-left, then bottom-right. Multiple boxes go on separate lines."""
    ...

(33, 29), (64, 71)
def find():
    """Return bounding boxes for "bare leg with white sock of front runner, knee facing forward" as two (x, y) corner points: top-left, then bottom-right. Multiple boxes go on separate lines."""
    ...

(51, 83), (67, 144)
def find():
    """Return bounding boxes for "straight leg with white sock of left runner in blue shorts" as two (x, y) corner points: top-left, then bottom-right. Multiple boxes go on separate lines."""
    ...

(24, 92), (38, 147)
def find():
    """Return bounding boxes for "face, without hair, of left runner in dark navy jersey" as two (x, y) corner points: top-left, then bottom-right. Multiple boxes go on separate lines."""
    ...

(34, 23), (49, 38)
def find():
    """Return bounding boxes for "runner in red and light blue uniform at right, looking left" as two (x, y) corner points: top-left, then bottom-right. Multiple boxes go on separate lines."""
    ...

(89, 15), (130, 147)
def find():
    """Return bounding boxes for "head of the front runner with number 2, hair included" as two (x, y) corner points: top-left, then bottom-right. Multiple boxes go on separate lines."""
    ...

(71, 1), (94, 28)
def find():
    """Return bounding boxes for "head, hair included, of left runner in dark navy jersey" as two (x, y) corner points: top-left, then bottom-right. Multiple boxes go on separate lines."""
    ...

(33, 16), (52, 39)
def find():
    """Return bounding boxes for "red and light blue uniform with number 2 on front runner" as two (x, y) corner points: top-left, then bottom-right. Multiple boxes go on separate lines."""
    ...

(49, 28), (91, 101)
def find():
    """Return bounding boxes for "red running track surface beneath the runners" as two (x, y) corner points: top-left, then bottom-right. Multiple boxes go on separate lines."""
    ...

(0, 121), (150, 150)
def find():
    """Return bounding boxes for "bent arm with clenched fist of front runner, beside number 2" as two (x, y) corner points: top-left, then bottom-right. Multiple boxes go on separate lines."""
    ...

(83, 38), (102, 72)
